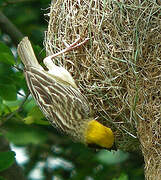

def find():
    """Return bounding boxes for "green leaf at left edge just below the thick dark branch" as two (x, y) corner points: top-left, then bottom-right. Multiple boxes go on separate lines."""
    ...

(0, 42), (15, 65)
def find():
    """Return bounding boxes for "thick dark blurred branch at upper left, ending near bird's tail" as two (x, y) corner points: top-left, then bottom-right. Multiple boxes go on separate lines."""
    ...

(0, 11), (23, 45)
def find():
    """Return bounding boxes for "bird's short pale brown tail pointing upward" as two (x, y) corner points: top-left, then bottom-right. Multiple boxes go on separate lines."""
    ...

(17, 37), (42, 68)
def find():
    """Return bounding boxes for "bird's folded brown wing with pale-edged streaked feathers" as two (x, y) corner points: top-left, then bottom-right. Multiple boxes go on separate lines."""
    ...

(25, 67), (90, 132)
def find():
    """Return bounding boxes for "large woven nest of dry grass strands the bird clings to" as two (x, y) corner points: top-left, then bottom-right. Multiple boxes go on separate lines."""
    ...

(45, 0), (161, 177)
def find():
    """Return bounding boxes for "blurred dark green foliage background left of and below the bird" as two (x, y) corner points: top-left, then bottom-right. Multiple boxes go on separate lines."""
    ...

(0, 0), (144, 180)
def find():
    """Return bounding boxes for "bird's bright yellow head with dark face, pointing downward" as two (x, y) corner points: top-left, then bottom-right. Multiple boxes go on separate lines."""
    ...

(85, 120), (114, 149)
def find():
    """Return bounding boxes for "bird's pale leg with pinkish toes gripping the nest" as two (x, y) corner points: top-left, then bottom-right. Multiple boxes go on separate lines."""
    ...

(43, 37), (89, 70)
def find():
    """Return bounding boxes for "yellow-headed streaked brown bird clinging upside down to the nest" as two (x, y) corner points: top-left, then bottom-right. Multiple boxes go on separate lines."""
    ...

(17, 37), (114, 150)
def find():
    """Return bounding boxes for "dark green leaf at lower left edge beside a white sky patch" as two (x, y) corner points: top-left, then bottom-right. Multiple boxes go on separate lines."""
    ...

(0, 151), (15, 171)
